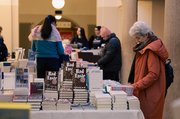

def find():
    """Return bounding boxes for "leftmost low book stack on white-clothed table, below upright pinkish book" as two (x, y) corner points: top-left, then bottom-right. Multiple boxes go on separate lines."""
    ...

(27, 94), (42, 111)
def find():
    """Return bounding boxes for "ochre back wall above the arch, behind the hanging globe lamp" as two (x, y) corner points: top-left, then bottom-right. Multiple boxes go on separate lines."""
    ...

(19, 0), (96, 38)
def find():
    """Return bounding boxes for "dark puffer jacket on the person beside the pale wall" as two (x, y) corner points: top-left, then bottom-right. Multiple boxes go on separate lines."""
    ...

(97, 33), (122, 72)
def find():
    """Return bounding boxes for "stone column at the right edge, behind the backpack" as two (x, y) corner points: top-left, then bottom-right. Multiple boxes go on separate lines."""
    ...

(164, 0), (180, 119)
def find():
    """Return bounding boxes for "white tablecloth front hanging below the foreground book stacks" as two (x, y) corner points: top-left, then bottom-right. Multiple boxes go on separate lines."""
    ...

(31, 110), (144, 119)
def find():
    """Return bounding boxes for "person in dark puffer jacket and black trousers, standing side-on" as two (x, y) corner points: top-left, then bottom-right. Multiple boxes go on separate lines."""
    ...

(97, 27), (122, 82)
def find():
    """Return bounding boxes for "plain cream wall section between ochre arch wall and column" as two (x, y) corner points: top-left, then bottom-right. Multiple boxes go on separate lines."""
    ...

(96, 0), (122, 38)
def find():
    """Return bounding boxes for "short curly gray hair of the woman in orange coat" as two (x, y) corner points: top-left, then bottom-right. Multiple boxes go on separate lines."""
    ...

(129, 21), (153, 37)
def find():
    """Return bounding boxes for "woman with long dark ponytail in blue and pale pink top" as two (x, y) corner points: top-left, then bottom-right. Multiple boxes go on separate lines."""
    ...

(29, 15), (64, 78)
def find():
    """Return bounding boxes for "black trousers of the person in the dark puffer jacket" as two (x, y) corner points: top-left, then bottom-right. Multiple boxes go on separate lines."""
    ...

(103, 71), (119, 82)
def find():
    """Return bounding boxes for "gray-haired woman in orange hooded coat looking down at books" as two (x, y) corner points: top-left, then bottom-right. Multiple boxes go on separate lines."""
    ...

(128, 21), (168, 119)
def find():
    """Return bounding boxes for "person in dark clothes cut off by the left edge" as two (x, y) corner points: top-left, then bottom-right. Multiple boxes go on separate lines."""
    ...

(0, 26), (8, 62)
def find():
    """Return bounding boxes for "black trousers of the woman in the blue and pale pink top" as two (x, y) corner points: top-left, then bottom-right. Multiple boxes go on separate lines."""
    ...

(36, 58), (60, 78)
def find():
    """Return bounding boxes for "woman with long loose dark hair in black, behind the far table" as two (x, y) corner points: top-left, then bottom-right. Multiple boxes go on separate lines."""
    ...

(71, 27), (88, 49)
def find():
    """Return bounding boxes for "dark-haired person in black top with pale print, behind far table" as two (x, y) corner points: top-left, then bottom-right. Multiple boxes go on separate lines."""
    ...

(88, 26), (103, 49)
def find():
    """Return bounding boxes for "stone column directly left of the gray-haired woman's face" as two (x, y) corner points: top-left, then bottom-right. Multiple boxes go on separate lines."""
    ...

(121, 0), (137, 83)
